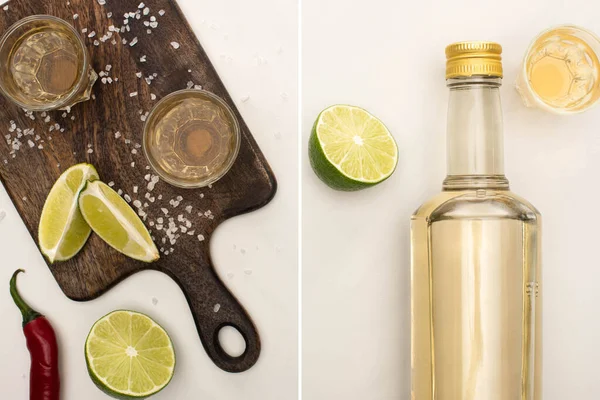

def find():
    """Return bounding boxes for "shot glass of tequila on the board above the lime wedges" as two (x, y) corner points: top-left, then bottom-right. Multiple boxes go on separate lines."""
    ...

(144, 90), (240, 188)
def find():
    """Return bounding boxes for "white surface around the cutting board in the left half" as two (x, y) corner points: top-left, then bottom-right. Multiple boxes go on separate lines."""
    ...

(0, 0), (298, 400)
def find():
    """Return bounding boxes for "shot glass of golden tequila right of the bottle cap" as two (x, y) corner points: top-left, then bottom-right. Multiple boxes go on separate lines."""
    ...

(516, 25), (600, 114)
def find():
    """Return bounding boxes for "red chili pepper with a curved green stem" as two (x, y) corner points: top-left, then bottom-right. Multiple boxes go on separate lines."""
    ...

(10, 269), (60, 400)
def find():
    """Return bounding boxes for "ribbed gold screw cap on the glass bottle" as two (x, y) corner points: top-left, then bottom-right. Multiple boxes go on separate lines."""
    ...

(446, 42), (502, 79)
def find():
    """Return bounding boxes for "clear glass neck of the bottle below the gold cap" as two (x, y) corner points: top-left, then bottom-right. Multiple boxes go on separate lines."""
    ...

(444, 76), (508, 190)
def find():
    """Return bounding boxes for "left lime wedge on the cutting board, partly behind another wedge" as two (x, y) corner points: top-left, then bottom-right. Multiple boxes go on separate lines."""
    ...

(38, 164), (98, 263)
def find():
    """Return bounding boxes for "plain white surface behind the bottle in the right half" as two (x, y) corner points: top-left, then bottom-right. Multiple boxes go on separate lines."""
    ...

(302, 0), (600, 400)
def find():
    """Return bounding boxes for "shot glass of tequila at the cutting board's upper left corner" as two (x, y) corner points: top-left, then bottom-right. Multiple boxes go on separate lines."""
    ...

(0, 15), (98, 111)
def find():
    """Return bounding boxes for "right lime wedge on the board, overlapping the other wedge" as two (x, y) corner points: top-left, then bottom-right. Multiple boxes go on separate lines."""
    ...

(79, 181), (159, 262)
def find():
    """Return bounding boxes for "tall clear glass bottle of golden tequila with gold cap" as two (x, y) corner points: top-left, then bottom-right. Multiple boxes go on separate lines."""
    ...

(411, 42), (542, 400)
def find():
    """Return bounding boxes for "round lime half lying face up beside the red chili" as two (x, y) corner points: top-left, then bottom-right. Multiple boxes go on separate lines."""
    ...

(85, 311), (175, 399)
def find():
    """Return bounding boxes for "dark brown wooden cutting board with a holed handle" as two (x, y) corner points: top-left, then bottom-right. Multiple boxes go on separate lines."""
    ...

(0, 0), (276, 372)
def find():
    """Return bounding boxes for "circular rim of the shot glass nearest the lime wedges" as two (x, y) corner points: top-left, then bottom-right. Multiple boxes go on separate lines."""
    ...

(142, 89), (242, 189)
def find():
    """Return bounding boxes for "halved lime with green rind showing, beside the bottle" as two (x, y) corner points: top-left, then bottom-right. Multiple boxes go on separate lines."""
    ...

(309, 105), (398, 191)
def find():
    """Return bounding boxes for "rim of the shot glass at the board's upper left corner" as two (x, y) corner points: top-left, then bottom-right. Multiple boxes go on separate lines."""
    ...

(0, 14), (90, 111)
